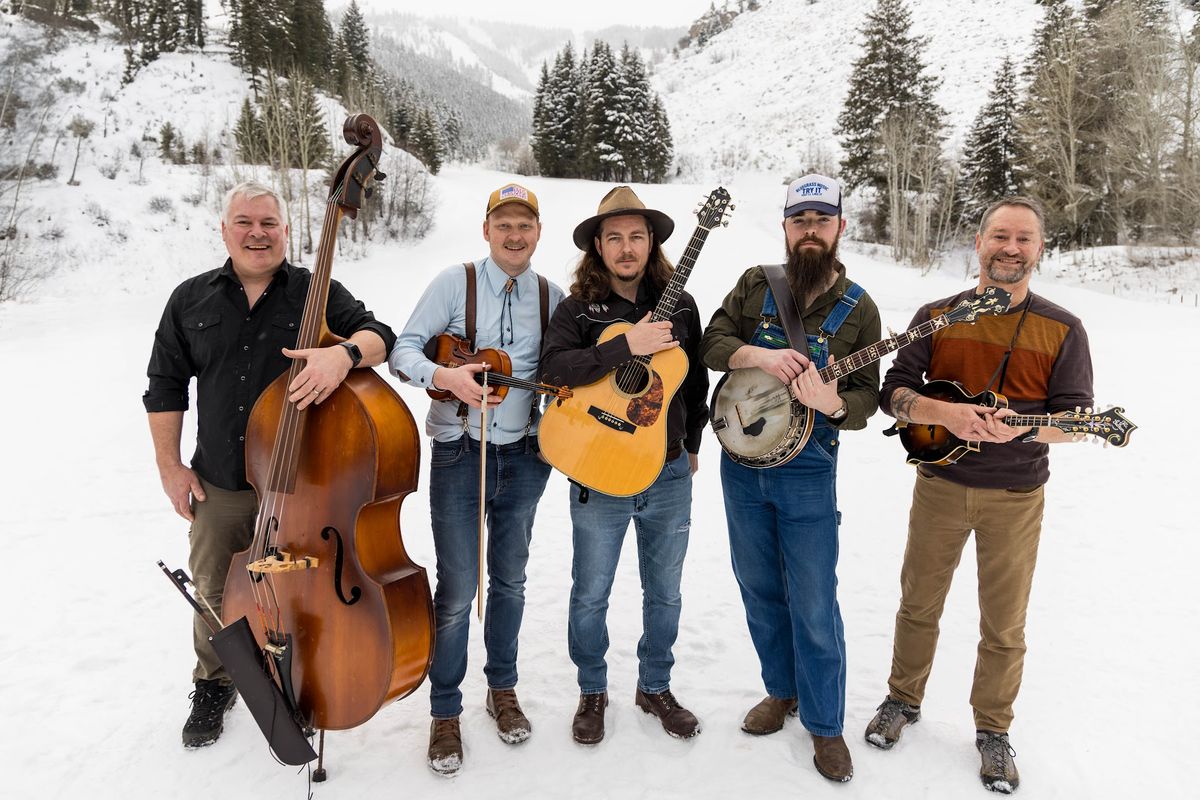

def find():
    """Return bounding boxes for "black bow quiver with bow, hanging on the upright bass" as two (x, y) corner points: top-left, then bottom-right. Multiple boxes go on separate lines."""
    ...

(158, 561), (324, 767)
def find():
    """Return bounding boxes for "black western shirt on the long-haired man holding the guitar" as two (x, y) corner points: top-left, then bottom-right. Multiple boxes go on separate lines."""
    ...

(541, 281), (708, 453)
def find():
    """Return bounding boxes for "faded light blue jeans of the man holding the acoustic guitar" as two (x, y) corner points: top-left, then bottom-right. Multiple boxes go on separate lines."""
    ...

(566, 452), (691, 694)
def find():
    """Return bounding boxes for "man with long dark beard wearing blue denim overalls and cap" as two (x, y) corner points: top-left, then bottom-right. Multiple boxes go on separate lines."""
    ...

(700, 175), (880, 782)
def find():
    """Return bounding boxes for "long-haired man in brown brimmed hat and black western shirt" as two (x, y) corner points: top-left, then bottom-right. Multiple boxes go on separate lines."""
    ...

(541, 186), (708, 745)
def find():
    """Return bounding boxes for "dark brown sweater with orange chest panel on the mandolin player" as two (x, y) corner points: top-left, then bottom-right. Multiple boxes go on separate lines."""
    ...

(880, 289), (1092, 488)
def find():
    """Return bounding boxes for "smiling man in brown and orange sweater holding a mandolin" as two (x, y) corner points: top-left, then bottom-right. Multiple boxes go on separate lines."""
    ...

(866, 197), (1092, 794)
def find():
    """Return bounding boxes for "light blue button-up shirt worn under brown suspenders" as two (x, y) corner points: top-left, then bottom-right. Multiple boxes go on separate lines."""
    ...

(388, 258), (563, 445)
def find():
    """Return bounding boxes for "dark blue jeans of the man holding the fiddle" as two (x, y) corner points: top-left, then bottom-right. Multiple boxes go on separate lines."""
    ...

(430, 435), (550, 718)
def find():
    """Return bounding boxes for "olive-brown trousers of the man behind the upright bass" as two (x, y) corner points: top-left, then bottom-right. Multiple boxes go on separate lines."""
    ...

(187, 479), (258, 684)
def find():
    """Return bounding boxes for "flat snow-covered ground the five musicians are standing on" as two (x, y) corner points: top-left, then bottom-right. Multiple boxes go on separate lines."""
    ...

(0, 164), (1200, 799)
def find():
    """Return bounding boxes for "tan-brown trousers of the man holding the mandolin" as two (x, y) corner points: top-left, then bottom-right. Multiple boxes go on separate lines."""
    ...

(888, 471), (1044, 733)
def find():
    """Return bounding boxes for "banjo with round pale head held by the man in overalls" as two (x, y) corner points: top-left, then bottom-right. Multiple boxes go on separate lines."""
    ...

(709, 287), (1012, 469)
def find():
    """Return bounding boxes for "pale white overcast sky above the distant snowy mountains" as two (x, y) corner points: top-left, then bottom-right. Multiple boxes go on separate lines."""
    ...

(343, 0), (712, 30)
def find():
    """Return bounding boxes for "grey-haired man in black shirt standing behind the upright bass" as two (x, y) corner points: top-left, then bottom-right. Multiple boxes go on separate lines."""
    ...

(142, 182), (396, 747)
